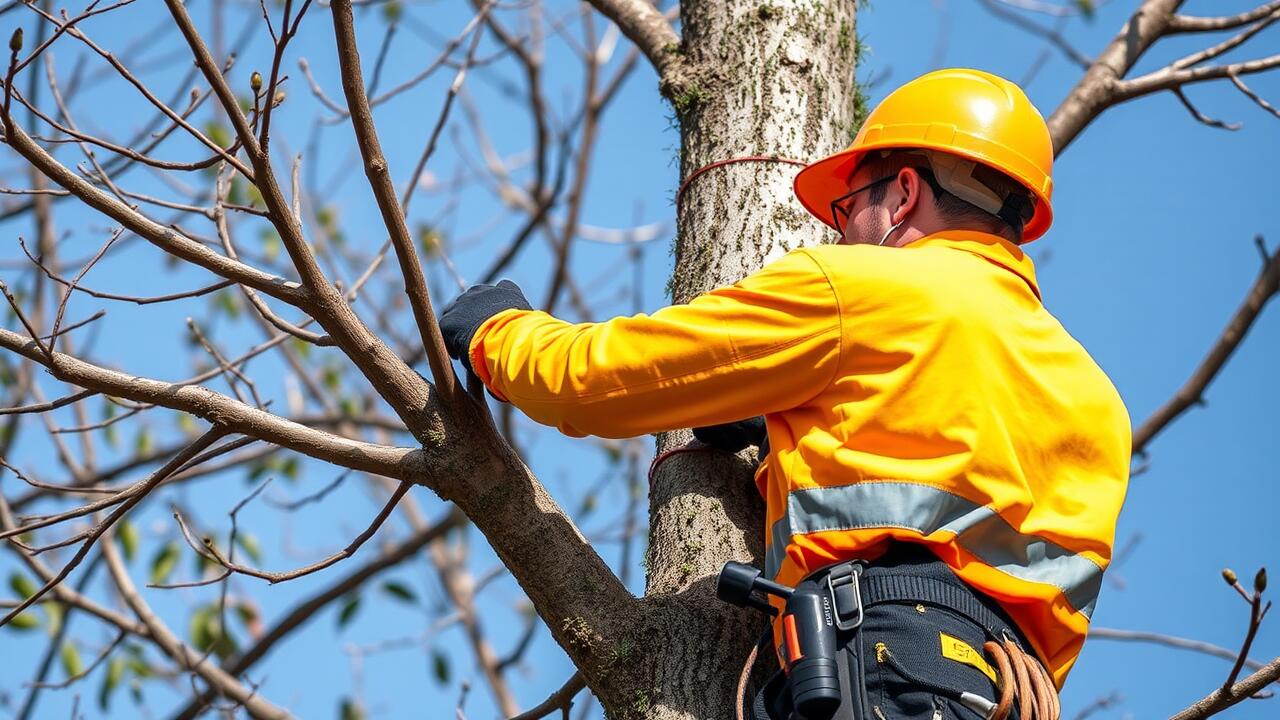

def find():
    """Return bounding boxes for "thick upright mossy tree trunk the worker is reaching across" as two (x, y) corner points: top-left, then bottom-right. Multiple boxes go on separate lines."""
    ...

(602, 0), (860, 719)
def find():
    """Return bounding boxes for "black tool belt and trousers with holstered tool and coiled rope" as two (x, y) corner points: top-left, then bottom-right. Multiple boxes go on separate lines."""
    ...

(716, 546), (1061, 720)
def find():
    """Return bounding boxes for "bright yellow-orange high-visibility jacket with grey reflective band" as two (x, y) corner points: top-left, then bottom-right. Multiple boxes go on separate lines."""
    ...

(471, 231), (1130, 687)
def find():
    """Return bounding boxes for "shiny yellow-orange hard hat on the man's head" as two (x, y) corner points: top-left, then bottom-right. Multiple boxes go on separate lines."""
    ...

(795, 68), (1053, 242)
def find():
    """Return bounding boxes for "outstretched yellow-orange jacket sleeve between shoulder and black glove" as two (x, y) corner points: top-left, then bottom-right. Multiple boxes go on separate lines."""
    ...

(471, 250), (841, 437)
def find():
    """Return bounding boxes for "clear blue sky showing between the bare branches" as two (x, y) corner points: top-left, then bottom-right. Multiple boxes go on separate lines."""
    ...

(0, 0), (1280, 719)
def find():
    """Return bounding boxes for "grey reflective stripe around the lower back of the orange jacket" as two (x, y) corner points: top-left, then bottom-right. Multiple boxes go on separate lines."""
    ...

(764, 482), (1102, 618)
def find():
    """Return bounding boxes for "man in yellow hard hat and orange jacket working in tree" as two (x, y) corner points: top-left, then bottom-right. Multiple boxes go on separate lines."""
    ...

(440, 69), (1130, 720)
